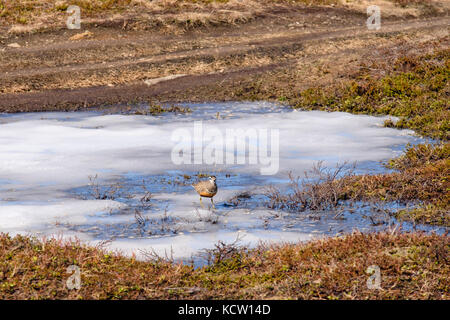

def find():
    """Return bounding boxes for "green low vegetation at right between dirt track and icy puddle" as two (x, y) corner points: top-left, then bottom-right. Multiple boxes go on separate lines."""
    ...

(295, 50), (450, 140)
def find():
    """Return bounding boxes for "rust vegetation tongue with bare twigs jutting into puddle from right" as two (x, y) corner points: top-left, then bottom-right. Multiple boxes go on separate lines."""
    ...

(266, 143), (450, 227)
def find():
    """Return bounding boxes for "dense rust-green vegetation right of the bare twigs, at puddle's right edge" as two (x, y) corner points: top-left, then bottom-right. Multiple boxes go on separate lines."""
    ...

(341, 143), (450, 227)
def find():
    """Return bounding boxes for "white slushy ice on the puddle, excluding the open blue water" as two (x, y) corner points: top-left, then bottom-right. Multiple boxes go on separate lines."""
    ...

(0, 103), (426, 257)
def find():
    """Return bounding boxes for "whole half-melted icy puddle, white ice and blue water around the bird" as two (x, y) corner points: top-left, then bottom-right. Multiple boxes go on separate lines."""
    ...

(0, 102), (442, 258)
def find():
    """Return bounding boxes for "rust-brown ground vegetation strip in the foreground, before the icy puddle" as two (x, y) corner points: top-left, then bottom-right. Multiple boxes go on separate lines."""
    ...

(0, 233), (450, 299)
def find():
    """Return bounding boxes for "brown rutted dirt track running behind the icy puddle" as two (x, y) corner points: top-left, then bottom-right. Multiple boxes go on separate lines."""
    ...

(0, 8), (449, 112)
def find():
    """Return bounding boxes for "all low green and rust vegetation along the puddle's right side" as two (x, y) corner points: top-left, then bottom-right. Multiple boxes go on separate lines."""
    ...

(251, 49), (450, 226)
